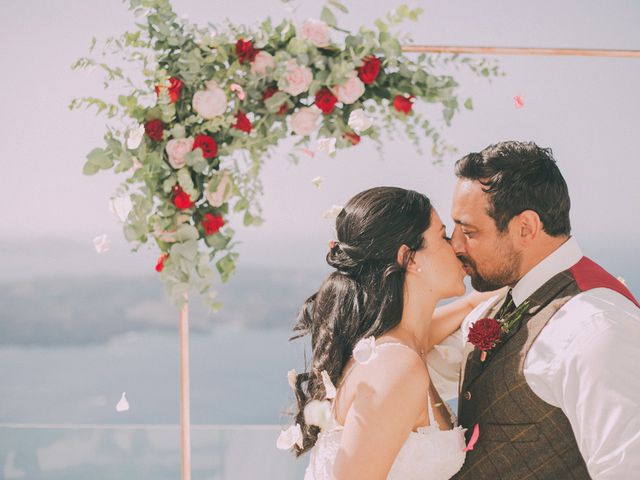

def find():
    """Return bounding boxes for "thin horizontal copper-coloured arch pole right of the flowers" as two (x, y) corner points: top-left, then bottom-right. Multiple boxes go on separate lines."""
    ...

(402, 45), (640, 58)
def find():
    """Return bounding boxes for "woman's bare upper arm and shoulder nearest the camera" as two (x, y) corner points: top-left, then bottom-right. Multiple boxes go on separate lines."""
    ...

(333, 348), (429, 480)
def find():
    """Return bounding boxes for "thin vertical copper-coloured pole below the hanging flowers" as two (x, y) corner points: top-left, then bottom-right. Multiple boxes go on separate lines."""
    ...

(180, 294), (191, 480)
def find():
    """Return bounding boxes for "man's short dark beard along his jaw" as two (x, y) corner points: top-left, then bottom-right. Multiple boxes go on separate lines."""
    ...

(458, 249), (522, 292)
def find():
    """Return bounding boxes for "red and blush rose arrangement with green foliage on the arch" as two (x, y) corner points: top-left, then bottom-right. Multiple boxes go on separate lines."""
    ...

(70, 0), (497, 307)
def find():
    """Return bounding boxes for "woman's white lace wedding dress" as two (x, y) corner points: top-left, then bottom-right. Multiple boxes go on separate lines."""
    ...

(304, 342), (466, 480)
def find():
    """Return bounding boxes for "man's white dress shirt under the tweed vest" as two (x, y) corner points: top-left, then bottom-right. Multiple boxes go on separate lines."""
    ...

(427, 238), (640, 480)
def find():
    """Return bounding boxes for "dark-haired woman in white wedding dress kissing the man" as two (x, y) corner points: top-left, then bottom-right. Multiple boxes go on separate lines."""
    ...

(288, 187), (487, 480)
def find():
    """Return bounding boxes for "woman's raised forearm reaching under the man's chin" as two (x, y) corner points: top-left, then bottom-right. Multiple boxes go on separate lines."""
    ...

(425, 287), (506, 349)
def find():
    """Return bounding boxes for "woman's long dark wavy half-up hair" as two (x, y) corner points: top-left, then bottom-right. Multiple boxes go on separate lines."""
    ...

(292, 187), (432, 456)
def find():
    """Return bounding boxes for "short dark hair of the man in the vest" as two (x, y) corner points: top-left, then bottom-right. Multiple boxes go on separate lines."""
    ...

(455, 141), (571, 237)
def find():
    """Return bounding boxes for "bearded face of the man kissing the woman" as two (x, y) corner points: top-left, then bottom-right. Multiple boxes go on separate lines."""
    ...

(451, 179), (522, 292)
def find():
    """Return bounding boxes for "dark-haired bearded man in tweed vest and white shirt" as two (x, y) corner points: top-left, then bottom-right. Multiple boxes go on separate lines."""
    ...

(444, 142), (640, 480)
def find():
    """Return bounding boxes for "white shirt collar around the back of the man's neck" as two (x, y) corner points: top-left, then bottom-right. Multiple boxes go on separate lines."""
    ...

(511, 237), (582, 306)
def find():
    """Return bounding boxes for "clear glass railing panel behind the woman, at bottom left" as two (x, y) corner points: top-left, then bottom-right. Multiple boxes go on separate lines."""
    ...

(0, 424), (308, 480)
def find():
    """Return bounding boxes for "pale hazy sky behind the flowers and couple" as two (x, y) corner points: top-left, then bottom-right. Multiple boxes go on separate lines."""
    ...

(0, 0), (640, 284)
